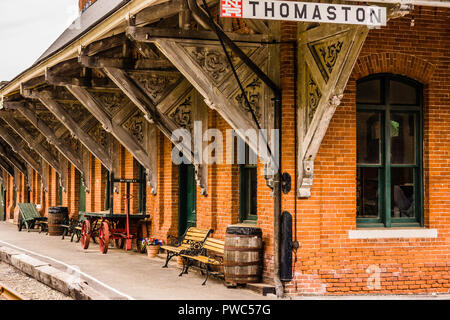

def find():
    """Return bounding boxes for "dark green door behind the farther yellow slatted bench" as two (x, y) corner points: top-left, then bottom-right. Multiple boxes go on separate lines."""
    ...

(178, 164), (197, 235)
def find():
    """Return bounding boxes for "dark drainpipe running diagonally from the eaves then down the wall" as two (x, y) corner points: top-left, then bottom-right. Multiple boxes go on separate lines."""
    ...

(187, 0), (284, 298)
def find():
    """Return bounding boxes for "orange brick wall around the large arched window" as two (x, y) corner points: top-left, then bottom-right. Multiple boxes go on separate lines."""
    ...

(282, 7), (450, 294)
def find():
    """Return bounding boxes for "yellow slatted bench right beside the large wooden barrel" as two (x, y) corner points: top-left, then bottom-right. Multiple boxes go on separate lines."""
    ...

(180, 238), (225, 286)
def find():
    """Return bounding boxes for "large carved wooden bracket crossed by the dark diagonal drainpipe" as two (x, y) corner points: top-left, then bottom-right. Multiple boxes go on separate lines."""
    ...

(137, 34), (270, 160)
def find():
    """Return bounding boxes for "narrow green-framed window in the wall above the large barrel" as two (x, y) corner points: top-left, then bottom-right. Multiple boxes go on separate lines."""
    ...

(239, 144), (258, 224)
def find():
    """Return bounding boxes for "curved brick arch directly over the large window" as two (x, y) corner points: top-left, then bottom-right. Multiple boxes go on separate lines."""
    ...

(353, 52), (435, 84)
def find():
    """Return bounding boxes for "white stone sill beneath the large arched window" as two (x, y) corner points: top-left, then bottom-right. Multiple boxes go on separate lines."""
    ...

(348, 228), (437, 239)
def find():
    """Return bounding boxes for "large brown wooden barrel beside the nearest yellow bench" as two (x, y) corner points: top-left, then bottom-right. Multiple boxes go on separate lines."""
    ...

(224, 224), (263, 285)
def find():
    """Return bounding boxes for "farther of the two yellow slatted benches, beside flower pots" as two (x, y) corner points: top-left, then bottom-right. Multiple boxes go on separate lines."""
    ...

(161, 227), (213, 268)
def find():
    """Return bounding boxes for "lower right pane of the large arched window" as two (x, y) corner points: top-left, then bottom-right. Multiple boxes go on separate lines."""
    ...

(391, 168), (415, 218)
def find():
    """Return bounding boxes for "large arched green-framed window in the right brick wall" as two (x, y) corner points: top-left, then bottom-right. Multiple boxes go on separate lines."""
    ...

(356, 74), (423, 228)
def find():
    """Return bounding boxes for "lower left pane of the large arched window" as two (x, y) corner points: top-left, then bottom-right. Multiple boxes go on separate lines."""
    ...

(357, 168), (379, 218)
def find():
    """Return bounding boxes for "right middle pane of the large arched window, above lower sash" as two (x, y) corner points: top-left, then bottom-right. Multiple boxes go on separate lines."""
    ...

(391, 113), (416, 164)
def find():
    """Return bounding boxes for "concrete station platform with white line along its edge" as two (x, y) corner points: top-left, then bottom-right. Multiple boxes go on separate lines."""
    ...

(0, 222), (276, 300)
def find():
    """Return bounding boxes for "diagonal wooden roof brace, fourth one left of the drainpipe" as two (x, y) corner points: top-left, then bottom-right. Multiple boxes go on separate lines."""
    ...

(21, 90), (112, 170)
